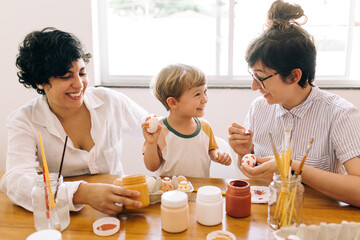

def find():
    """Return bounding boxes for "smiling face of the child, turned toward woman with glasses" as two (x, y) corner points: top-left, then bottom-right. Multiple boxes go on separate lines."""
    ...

(177, 85), (208, 117)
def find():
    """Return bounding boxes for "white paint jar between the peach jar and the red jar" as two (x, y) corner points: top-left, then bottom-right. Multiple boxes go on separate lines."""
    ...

(196, 186), (223, 226)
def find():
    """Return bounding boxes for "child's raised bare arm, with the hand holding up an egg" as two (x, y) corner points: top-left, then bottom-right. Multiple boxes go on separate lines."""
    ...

(141, 121), (163, 172)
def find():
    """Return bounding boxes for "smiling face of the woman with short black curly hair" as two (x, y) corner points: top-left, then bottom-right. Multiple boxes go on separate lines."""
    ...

(44, 59), (88, 114)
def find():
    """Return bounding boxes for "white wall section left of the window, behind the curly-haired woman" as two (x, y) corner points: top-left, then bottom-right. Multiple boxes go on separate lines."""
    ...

(0, 0), (94, 169)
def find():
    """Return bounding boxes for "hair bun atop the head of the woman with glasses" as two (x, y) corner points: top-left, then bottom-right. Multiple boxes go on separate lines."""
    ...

(266, 0), (307, 30)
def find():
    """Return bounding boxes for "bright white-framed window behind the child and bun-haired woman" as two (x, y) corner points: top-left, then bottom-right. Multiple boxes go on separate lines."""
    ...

(98, 0), (360, 87)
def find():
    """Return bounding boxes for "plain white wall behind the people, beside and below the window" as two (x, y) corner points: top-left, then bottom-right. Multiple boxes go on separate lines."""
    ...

(0, 0), (360, 179)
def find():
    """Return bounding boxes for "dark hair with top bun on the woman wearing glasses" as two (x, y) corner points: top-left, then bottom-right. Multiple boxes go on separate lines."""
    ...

(245, 0), (316, 88)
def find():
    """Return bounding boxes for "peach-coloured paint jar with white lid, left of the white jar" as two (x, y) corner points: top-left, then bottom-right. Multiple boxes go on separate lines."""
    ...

(161, 190), (189, 233)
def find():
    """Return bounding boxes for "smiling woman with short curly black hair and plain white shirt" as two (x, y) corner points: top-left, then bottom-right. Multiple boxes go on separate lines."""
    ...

(0, 28), (148, 214)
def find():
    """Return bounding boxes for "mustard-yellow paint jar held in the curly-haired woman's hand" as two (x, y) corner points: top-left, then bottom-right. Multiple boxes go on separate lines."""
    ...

(121, 174), (150, 209)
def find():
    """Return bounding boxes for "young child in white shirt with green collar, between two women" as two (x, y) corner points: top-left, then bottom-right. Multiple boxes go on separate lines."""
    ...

(142, 64), (231, 177)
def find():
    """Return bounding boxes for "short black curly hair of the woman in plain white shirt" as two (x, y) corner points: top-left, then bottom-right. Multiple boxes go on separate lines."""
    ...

(16, 27), (91, 95)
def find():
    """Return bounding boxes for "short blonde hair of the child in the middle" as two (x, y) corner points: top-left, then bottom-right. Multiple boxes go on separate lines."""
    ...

(150, 63), (206, 111)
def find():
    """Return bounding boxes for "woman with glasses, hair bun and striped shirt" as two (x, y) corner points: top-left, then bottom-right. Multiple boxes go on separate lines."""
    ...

(229, 0), (360, 207)
